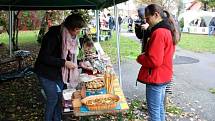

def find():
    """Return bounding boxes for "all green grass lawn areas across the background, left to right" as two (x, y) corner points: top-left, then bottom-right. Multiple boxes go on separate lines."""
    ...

(0, 31), (215, 63)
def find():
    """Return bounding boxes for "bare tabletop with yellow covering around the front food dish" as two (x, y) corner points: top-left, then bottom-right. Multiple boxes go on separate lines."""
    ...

(65, 79), (129, 117)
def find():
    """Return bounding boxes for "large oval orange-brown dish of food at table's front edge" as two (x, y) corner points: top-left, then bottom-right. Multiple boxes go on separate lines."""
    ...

(81, 94), (119, 110)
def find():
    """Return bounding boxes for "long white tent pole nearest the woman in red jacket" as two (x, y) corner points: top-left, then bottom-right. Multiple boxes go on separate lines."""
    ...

(114, 0), (122, 88)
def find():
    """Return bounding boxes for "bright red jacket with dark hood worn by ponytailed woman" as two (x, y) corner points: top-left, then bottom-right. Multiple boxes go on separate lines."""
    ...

(137, 28), (175, 84)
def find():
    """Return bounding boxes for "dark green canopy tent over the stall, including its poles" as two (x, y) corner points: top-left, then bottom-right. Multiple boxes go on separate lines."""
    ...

(0, 0), (128, 86)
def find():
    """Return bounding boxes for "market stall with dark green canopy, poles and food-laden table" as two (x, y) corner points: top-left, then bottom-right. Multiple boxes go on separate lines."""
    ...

(0, 0), (128, 119)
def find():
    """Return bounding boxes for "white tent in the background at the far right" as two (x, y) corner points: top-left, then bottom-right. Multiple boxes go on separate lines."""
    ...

(178, 10), (215, 34)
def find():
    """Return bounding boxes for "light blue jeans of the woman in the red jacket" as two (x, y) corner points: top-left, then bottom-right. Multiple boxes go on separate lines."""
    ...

(146, 84), (166, 121)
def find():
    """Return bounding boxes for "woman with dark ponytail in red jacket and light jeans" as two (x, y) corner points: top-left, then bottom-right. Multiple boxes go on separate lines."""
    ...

(137, 4), (175, 121)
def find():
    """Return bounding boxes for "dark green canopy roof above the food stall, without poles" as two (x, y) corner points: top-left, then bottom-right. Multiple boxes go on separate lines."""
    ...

(0, 0), (127, 10)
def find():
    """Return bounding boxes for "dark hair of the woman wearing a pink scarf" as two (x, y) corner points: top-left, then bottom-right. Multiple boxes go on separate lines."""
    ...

(63, 14), (86, 29)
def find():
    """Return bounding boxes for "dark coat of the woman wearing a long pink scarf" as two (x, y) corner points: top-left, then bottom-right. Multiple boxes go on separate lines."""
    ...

(34, 26), (65, 80)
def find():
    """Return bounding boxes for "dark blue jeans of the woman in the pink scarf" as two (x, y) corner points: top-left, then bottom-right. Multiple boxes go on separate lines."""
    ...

(38, 76), (63, 121)
